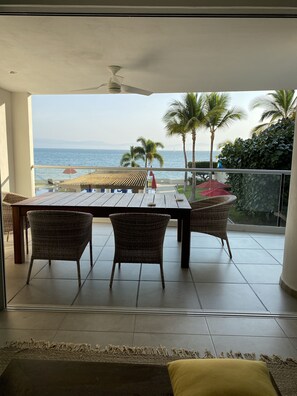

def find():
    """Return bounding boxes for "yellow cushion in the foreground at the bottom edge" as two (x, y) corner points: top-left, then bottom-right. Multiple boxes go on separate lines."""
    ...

(167, 359), (277, 396)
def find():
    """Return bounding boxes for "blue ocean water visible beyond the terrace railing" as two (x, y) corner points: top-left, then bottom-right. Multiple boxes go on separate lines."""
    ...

(34, 148), (219, 183)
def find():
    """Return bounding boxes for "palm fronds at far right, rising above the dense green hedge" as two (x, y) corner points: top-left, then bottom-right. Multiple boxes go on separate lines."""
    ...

(251, 89), (297, 134)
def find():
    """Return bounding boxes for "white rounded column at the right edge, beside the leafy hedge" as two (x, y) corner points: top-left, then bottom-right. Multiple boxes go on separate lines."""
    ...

(280, 113), (297, 297)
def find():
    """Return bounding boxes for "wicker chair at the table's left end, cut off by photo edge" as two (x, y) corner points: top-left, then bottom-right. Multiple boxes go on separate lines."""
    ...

(2, 192), (30, 254)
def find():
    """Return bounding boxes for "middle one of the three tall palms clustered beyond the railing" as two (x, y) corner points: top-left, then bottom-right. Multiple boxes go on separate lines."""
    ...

(164, 92), (204, 201)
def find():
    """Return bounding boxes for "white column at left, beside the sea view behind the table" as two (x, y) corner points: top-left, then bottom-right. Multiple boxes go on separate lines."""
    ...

(11, 92), (35, 197)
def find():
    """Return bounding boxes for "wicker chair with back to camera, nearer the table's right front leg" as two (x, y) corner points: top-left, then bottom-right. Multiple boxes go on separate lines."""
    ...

(109, 213), (170, 289)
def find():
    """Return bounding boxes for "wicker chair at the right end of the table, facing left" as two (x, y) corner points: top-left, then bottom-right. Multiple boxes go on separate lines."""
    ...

(191, 195), (237, 258)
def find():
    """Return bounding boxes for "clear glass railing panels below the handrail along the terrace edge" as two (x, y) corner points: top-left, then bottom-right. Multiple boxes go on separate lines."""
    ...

(35, 166), (290, 227)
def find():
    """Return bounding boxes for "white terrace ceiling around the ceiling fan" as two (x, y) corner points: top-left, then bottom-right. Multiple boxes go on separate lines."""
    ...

(0, 16), (297, 94)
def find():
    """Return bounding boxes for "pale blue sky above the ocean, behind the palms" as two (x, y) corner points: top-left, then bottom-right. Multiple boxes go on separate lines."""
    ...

(32, 91), (268, 150)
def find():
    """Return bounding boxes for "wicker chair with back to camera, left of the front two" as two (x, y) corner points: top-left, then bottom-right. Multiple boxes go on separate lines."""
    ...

(27, 210), (93, 287)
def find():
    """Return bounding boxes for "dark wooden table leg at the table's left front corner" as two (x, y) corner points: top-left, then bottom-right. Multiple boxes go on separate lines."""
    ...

(12, 206), (25, 264)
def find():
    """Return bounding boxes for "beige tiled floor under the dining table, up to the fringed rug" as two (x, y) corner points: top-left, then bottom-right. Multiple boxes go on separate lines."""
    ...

(0, 223), (297, 358)
